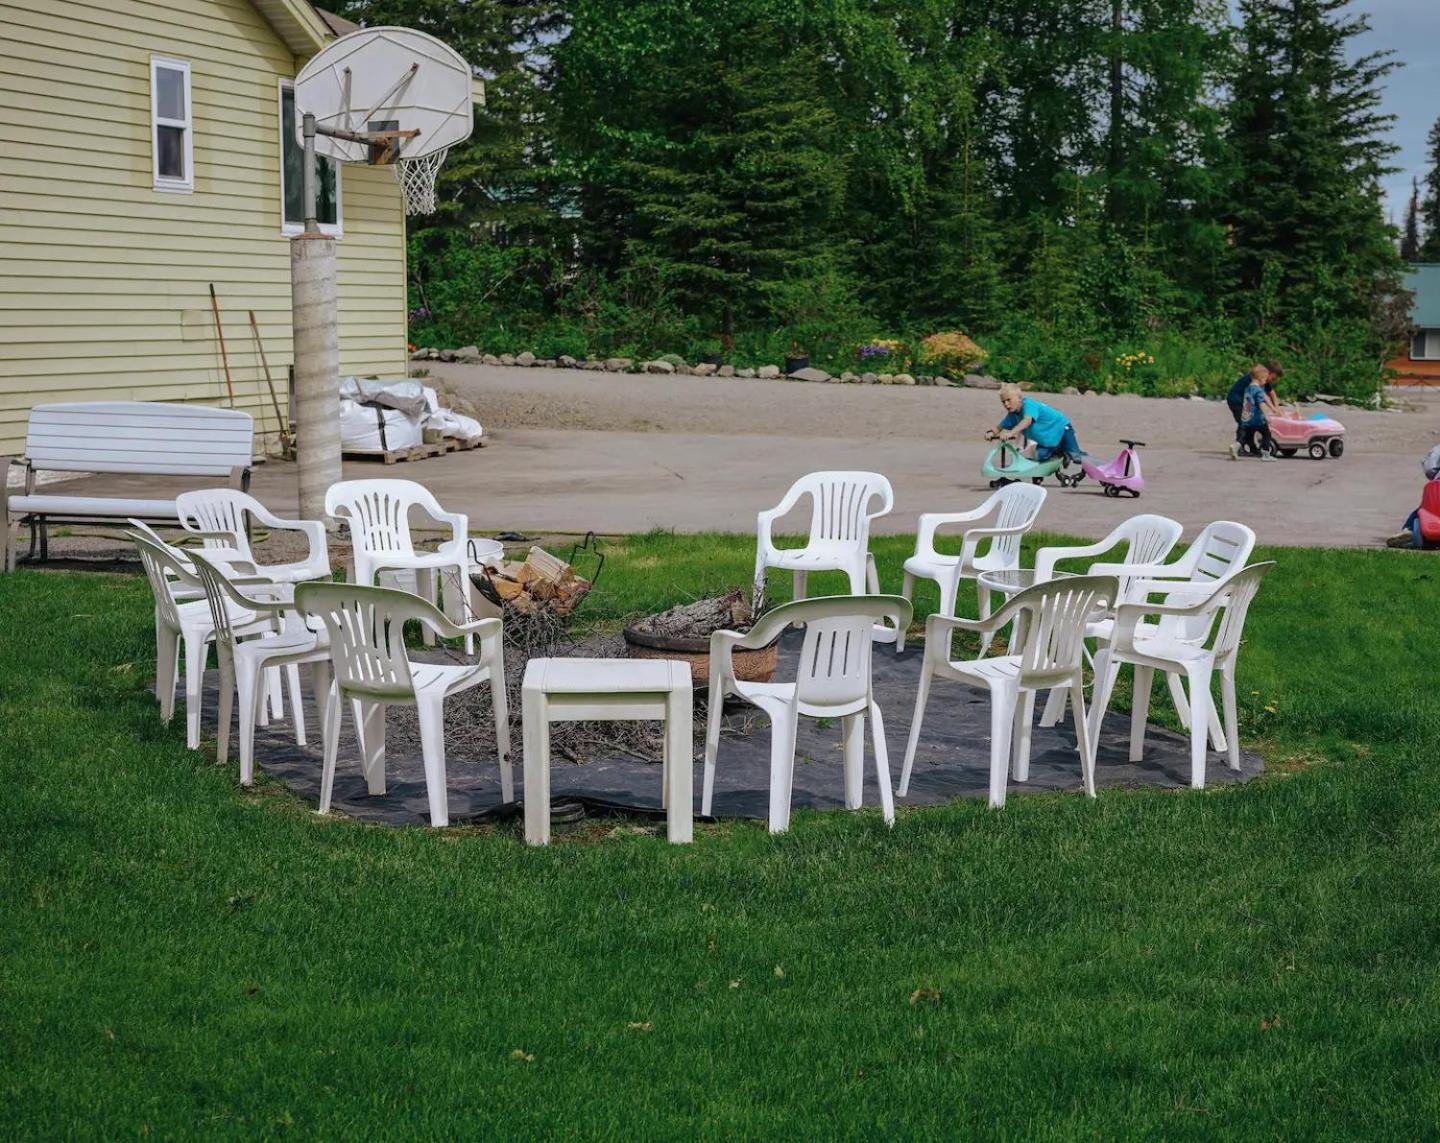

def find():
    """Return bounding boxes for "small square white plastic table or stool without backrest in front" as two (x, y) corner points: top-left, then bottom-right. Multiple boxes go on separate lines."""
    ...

(521, 659), (694, 845)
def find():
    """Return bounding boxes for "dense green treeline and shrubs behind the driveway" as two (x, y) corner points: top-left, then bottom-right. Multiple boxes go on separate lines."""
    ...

(385, 0), (1405, 400)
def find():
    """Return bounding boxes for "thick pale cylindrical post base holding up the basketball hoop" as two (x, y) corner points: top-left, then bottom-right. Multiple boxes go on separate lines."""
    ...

(289, 235), (340, 520)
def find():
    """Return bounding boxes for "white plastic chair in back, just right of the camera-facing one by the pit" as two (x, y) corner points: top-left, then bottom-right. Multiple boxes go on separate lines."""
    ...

(896, 484), (1045, 651)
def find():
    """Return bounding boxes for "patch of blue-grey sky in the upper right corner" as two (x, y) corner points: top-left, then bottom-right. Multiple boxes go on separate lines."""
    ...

(1351, 0), (1440, 218)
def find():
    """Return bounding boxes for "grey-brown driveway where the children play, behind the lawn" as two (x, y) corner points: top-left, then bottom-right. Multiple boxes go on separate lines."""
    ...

(22, 366), (1440, 546)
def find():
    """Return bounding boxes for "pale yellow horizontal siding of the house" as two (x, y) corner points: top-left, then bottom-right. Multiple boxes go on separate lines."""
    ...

(0, 0), (406, 453)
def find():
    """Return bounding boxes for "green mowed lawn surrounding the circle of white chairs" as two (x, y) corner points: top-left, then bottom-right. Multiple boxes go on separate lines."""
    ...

(0, 534), (1440, 1137)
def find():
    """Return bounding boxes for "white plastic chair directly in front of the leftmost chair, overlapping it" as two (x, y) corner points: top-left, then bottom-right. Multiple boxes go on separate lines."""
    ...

(185, 553), (330, 786)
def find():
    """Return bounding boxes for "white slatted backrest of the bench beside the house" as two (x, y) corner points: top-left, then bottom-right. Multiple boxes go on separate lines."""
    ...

(24, 400), (255, 476)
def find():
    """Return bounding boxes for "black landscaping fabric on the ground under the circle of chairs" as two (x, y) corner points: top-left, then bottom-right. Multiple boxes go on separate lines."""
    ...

(213, 632), (1263, 825)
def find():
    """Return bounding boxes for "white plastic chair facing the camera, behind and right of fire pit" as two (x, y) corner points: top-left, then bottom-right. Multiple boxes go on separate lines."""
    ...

(755, 472), (894, 599)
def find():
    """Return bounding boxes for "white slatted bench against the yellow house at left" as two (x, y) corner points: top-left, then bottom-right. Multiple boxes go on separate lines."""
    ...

(0, 400), (255, 572)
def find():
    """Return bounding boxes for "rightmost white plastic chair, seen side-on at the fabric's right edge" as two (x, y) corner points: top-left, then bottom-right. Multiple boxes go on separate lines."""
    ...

(1092, 563), (1274, 789)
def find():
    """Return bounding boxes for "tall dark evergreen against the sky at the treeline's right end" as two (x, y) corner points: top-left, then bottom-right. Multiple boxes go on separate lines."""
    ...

(1227, 0), (1400, 322)
